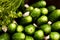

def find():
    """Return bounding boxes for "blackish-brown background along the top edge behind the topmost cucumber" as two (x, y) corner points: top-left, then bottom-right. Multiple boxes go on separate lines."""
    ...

(25, 0), (60, 8)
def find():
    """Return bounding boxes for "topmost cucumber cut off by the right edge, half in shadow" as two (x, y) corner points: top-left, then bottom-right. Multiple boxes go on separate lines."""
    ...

(48, 9), (60, 22)
